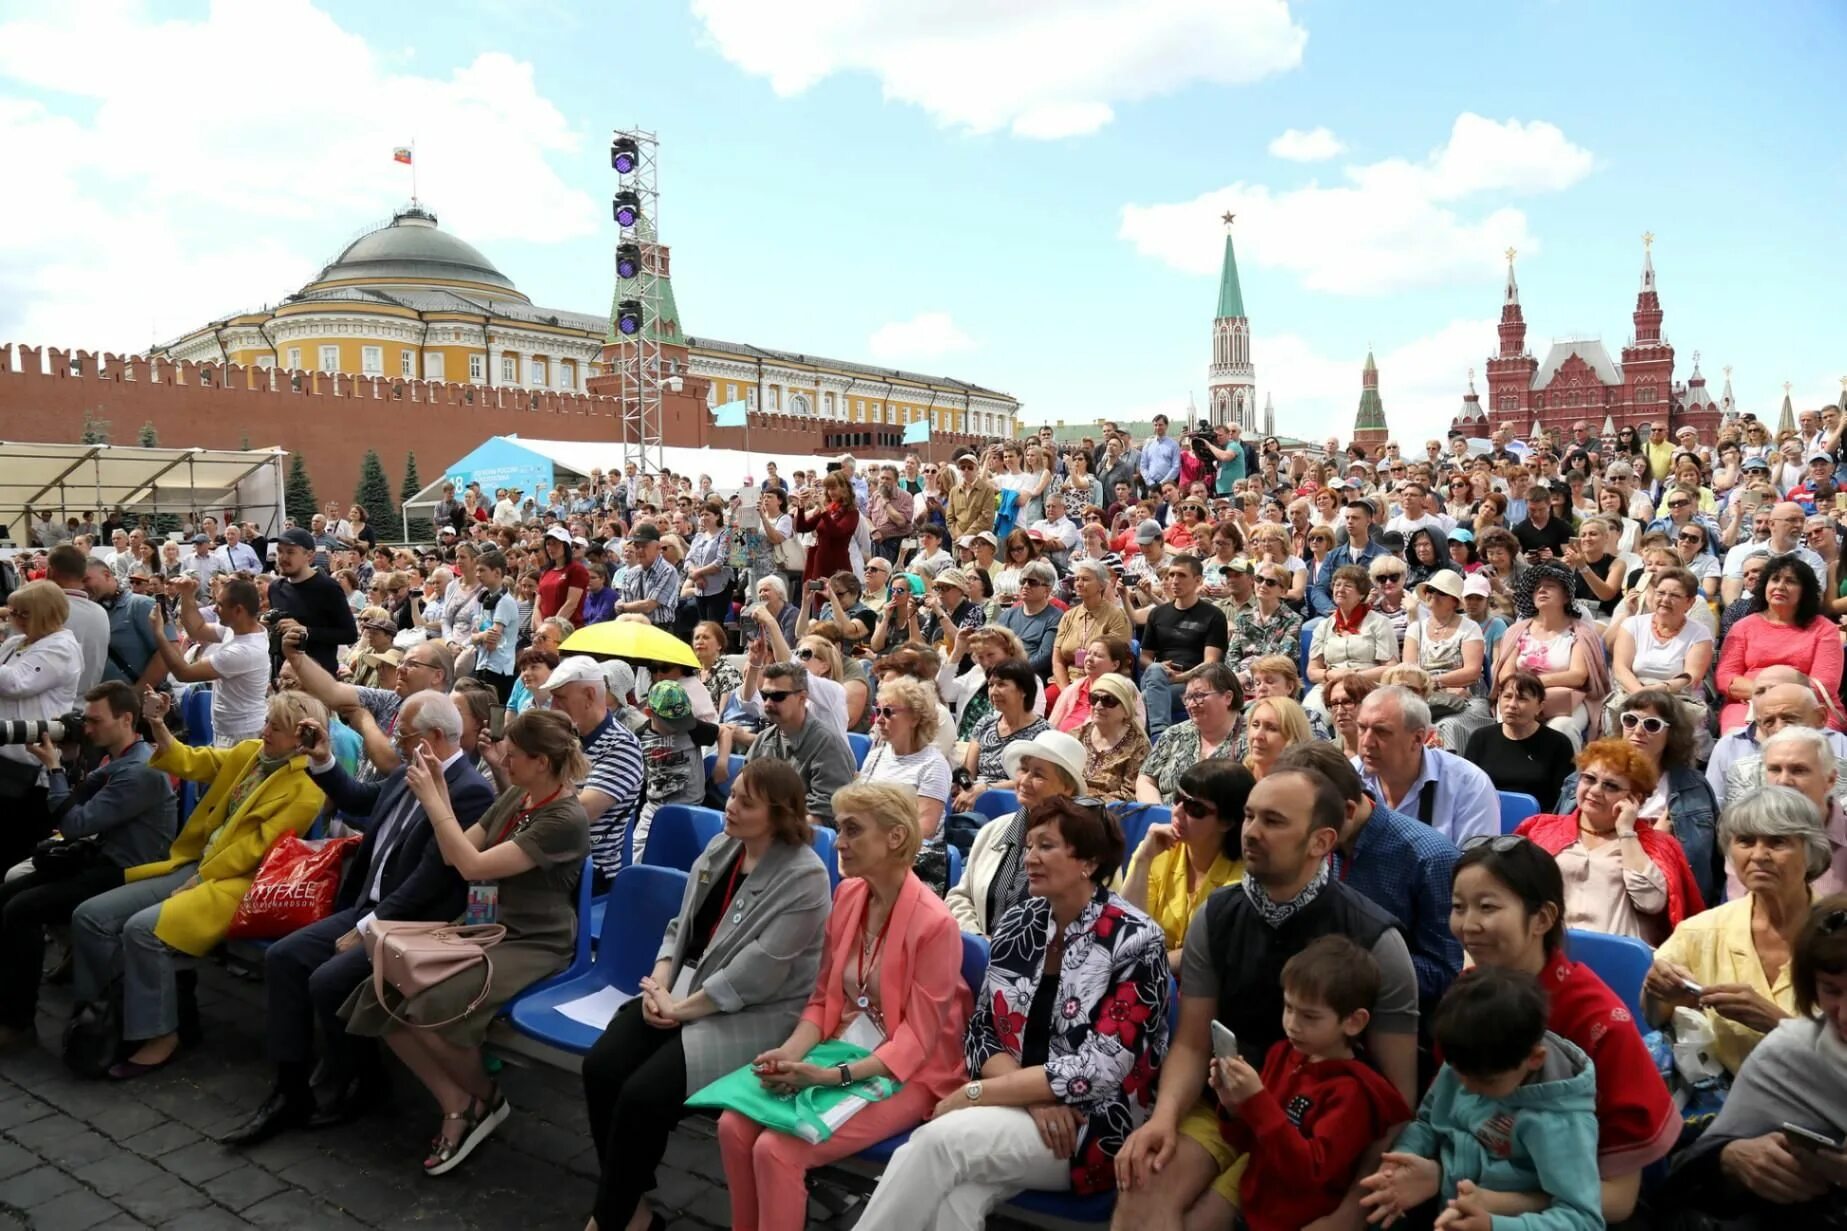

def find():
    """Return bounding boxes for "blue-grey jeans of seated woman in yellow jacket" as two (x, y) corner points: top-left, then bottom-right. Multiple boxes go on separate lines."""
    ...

(70, 863), (198, 1042)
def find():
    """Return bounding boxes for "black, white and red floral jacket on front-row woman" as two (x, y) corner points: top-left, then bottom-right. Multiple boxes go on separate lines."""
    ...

(966, 889), (1173, 1194)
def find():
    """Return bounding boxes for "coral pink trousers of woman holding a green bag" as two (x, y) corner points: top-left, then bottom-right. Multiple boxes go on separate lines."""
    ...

(718, 1085), (938, 1231)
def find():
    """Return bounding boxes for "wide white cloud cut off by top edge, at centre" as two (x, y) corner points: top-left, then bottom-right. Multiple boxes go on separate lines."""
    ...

(693, 0), (1308, 139)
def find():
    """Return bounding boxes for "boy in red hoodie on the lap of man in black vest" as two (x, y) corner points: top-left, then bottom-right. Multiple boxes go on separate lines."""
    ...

(1212, 935), (1411, 1231)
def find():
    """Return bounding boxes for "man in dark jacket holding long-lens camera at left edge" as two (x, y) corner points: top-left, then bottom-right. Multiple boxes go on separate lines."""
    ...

(0, 680), (179, 1048)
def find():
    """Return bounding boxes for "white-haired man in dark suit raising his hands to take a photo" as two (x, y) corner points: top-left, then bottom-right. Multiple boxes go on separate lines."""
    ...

(223, 691), (493, 1146)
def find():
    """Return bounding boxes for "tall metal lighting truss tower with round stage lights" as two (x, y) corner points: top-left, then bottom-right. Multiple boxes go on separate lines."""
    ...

(610, 129), (669, 475)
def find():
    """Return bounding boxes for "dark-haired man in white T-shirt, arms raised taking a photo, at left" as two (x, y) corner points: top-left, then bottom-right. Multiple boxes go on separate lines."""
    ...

(148, 577), (269, 749)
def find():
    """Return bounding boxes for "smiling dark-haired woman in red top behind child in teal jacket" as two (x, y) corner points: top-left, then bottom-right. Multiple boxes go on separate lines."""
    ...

(1450, 834), (1681, 1225)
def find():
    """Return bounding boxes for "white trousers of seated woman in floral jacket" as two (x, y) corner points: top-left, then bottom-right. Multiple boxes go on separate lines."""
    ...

(859, 1107), (1071, 1231)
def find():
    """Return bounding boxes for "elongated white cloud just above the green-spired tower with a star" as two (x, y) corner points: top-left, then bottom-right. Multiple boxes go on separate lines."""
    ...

(1117, 113), (1596, 296)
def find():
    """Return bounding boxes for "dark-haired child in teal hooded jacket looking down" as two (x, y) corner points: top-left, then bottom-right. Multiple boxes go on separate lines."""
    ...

(1361, 969), (1603, 1231)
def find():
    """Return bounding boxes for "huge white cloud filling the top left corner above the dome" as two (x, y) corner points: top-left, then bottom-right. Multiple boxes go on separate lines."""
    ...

(0, 0), (598, 349)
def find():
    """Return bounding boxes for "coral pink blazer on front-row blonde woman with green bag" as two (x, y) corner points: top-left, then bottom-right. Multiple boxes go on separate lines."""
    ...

(802, 874), (973, 1098)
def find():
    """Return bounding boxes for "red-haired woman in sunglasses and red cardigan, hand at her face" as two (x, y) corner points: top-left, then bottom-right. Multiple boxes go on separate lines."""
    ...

(1515, 737), (1705, 945)
